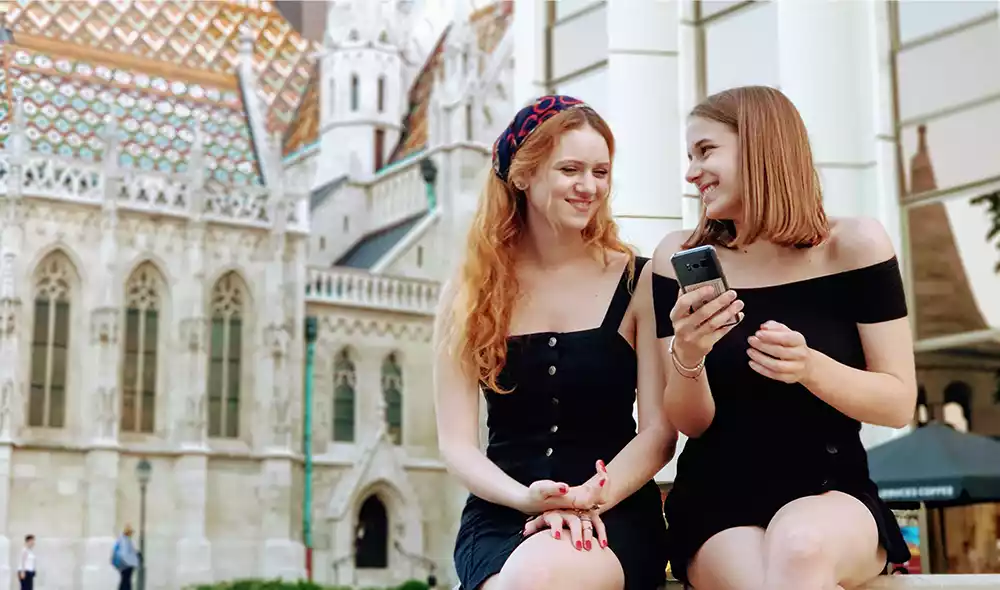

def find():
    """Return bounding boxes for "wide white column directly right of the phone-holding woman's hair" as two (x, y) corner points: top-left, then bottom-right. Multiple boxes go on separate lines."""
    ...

(777, 0), (878, 222)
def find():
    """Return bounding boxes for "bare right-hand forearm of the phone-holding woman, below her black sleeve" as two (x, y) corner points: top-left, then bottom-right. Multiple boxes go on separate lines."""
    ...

(801, 349), (915, 428)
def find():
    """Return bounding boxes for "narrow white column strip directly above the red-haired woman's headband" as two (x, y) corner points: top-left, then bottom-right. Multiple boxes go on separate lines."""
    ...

(511, 0), (548, 110)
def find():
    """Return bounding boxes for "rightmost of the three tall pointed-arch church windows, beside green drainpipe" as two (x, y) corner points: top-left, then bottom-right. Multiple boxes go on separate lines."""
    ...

(208, 272), (246, 438)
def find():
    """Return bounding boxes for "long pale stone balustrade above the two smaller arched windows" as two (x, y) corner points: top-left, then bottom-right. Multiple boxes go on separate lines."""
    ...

(306, 268), (441, 315)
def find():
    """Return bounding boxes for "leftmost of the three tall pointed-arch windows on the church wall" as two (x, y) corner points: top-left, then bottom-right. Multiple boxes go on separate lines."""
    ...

(28, 251), (77, 428)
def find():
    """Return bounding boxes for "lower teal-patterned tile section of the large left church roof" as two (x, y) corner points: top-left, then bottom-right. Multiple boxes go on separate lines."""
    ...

(0, 35), (260, 186)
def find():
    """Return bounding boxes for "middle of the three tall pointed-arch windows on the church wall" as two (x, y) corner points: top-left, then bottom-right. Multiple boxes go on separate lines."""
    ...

(121, 262), (164, 433)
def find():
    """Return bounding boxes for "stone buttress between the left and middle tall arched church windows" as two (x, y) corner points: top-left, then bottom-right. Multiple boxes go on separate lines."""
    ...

(81, 119), (124, 590)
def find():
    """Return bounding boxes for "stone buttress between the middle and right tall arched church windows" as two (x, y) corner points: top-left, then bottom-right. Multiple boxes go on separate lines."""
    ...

(170, 129), (213, 587)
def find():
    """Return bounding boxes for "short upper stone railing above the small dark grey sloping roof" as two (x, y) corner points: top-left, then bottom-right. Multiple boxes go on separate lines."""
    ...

(366, 153), (427, 226)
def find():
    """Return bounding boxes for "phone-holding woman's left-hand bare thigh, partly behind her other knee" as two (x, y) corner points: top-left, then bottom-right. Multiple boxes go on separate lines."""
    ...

(688, 526), (764, 590)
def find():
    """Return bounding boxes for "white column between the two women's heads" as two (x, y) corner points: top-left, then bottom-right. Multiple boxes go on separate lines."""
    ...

(607, 0), (681, 256)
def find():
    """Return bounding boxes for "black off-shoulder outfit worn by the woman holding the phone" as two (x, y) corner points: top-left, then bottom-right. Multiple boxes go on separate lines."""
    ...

(653, 258), (910, 582)
